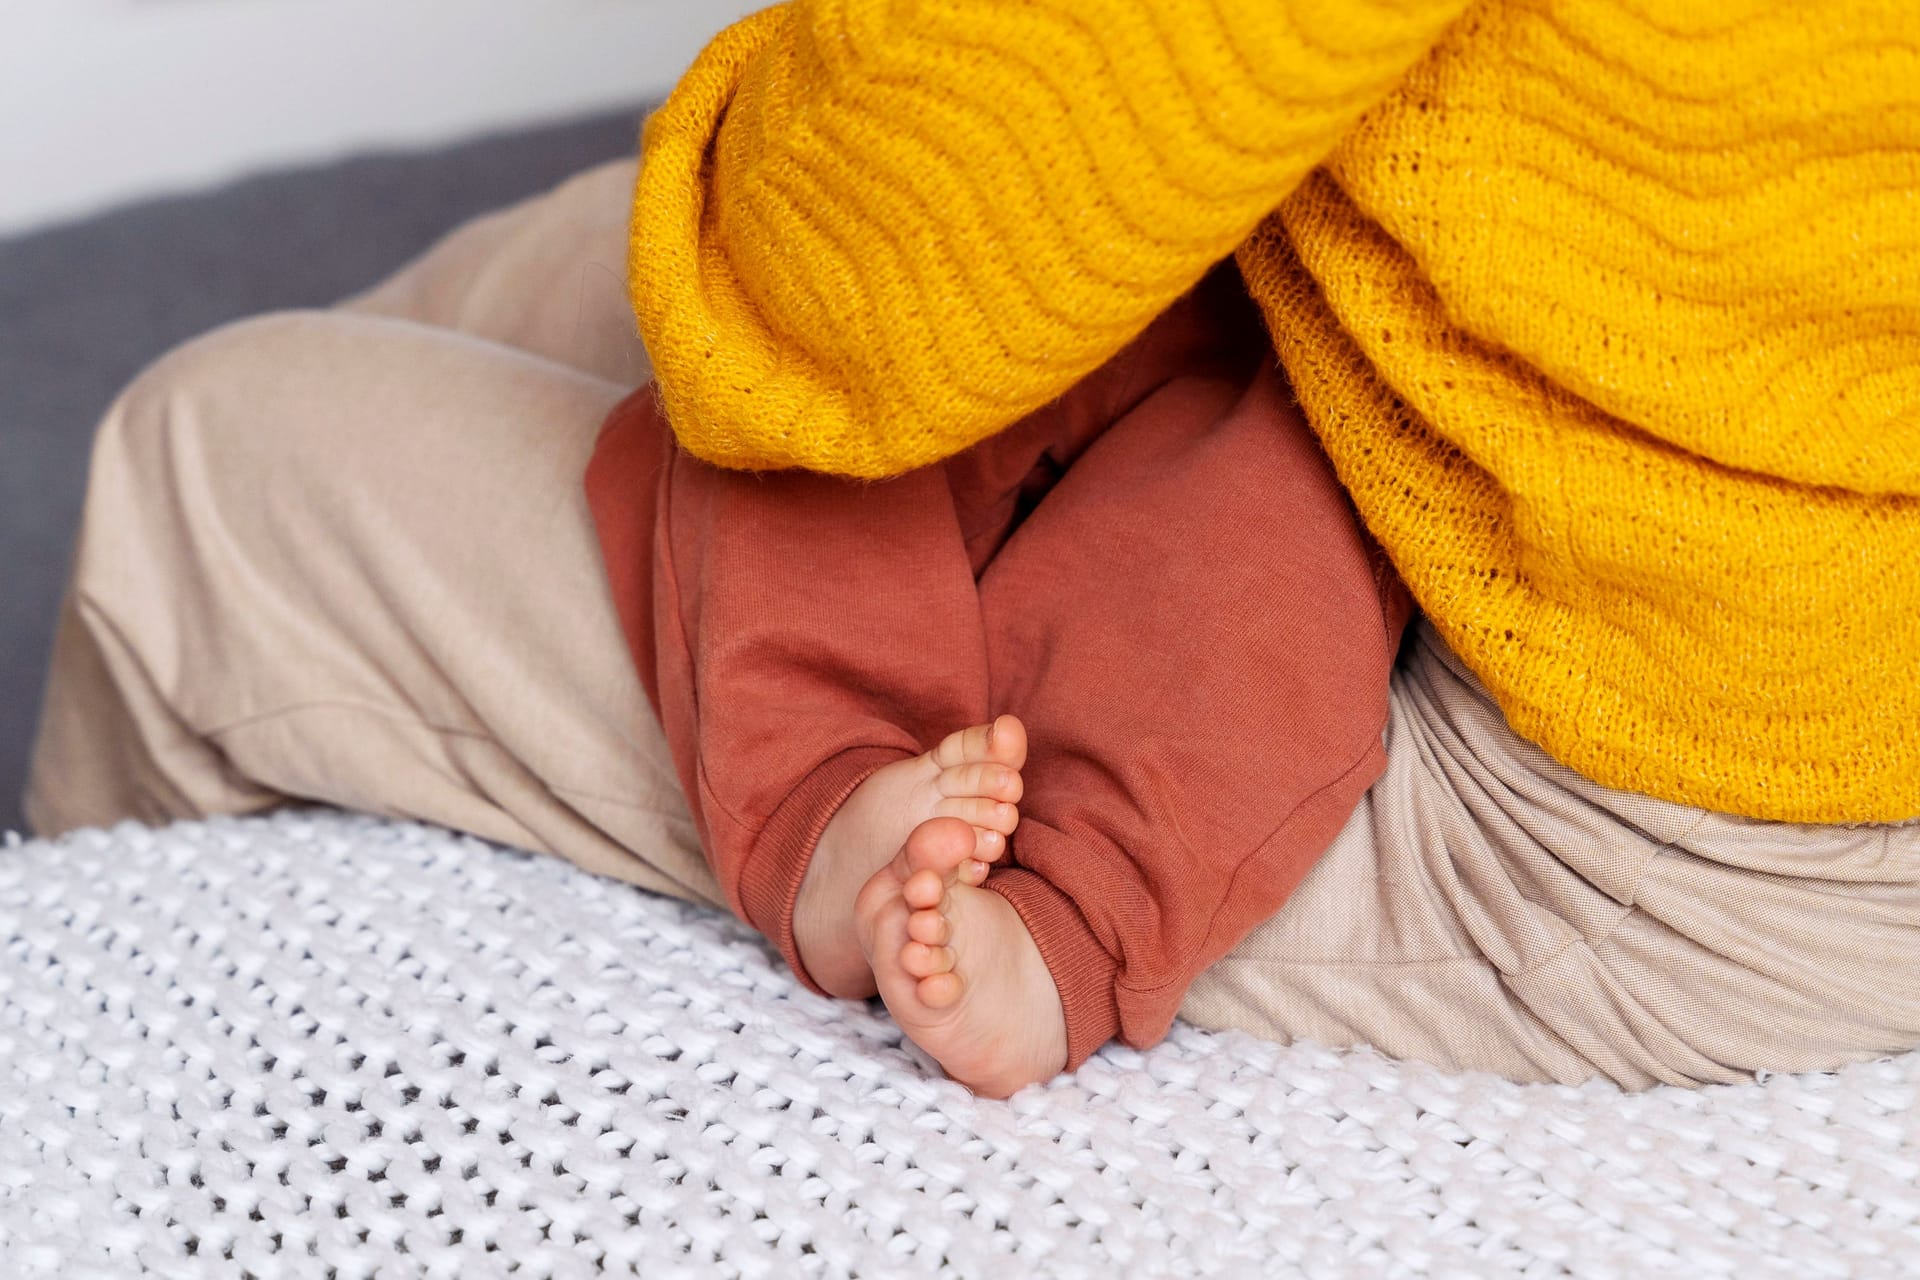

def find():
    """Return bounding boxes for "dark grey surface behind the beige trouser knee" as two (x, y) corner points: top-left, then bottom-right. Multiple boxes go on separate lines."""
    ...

(0, 107), (641, 831)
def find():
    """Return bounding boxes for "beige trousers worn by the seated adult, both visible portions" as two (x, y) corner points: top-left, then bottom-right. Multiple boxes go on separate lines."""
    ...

(27, 161), (1920, 1088)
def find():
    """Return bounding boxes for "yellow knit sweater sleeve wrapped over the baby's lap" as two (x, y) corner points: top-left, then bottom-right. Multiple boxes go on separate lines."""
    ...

(630, 0), (1467, 478)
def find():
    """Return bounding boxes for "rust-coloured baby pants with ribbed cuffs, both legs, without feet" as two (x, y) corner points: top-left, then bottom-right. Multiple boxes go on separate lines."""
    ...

(588, 267), (1407, 1065)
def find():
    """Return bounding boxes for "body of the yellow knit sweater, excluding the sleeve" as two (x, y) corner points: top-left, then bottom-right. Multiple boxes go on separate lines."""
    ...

(1240, 0), (1920, 821)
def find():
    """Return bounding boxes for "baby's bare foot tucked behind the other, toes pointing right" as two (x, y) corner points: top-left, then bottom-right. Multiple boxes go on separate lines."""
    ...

(793, 716), (1027, 1000)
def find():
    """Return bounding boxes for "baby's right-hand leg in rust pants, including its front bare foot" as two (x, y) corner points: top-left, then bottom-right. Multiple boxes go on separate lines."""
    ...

(862, 363), (1407, 1094)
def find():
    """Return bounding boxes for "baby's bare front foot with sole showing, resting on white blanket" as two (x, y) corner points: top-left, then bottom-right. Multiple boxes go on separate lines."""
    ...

(854, 819), (1068, 1098)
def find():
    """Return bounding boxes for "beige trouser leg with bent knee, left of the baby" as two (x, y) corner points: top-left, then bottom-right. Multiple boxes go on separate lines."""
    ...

(27, 161), (720, 902)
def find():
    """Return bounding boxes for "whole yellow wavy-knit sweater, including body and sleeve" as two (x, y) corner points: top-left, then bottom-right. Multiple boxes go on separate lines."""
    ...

(632, 0), (1920, 821)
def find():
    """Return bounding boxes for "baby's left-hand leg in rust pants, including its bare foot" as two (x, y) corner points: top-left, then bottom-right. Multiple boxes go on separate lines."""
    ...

(588, 391), (1025, 996)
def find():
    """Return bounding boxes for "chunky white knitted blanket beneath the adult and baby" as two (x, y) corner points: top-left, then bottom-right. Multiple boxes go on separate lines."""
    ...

(0, 812), (1920, 1280)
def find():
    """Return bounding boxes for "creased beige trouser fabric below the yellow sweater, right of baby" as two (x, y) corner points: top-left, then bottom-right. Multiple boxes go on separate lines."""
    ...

(1181, 624), (1920, 1088)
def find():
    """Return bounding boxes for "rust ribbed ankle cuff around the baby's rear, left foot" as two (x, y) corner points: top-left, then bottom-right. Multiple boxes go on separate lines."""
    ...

(737, 747), (914, 996)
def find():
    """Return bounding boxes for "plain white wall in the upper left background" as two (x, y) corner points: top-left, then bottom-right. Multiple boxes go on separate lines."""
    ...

(0, 0), (766, 234)
